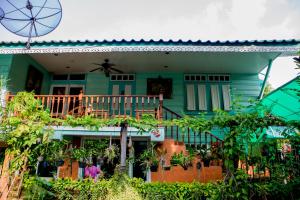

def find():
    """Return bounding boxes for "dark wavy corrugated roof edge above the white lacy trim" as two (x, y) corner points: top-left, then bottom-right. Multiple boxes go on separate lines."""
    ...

(0, 39), (300, 47)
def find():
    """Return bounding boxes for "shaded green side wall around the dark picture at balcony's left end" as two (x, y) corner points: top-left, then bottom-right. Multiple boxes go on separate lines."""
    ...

(8, 55), (50, 94)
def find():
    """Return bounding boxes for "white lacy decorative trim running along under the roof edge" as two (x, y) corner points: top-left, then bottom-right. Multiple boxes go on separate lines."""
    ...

(0, 45), (300, 54)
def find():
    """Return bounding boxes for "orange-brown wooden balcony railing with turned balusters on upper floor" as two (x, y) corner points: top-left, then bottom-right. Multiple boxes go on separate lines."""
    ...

(7, 93), (163, 119)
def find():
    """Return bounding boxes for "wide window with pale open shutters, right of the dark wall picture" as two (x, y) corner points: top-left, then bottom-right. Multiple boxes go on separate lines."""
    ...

(184, 74), (231, 111)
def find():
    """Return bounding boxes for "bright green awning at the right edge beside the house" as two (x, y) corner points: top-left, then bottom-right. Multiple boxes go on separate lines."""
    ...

(261, 76), (300, 121)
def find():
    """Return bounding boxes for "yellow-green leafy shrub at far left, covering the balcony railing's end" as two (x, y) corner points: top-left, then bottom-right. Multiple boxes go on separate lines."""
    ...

(1, 92), (53, 171)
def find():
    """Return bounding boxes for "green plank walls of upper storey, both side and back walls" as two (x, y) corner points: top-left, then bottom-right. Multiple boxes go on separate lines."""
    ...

(4, 55), (261, 115)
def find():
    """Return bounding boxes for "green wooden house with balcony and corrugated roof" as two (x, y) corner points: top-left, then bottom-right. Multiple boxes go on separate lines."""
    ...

(0, 40), (300, 181)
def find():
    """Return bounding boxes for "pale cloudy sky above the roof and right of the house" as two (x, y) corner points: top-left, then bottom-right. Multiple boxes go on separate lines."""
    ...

(0, 0), (300, 88)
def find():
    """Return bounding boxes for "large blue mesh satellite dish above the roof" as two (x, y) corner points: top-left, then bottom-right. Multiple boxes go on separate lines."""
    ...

(0, 0), (62, 49)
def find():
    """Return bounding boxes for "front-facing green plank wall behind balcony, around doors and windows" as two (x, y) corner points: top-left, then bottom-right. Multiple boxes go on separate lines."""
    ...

(85, 72), (261, 115)
